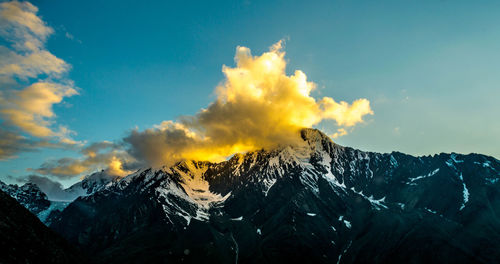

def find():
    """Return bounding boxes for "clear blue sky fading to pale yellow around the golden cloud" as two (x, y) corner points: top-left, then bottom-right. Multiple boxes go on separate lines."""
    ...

(0, 1), (500, 186)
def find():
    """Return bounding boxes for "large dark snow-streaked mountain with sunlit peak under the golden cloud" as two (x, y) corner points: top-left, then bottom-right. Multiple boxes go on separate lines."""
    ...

(50, 129), (500, 263)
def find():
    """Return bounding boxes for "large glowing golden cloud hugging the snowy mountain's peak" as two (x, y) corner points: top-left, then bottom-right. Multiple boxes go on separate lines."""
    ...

(124, 41), (373, 166)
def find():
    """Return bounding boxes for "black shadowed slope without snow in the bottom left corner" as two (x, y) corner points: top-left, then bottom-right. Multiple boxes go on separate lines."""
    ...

(0, 191), (84, 263)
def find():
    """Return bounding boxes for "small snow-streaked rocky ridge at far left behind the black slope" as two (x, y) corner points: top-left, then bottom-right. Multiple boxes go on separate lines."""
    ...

(0, 181), (50, 215)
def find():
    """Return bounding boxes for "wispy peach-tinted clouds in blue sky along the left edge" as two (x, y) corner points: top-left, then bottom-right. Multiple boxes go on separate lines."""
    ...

(0, 1), (79, 159)
